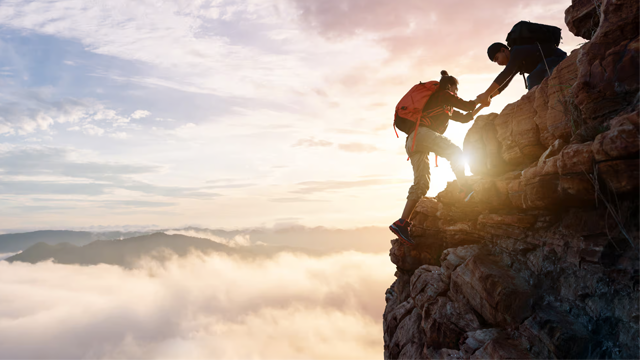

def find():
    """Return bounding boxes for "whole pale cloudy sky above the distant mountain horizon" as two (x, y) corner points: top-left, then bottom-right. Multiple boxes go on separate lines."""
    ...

(0, 0), (584, 229)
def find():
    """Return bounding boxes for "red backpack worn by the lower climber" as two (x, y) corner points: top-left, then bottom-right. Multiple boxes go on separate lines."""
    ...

(393, 81), (443, 151)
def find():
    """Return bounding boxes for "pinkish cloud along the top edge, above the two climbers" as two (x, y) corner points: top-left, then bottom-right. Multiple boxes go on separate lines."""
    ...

(291, 0), (568, 62)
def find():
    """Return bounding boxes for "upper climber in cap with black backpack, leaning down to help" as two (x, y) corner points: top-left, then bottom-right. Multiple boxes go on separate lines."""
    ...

(476, 21), (567, 106)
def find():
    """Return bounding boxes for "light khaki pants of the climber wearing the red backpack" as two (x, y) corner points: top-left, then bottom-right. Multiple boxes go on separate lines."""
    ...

(405, 126), (464, 200)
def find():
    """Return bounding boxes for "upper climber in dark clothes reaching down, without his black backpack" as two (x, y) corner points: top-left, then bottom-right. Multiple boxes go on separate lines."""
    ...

(476, 43), (567, 106)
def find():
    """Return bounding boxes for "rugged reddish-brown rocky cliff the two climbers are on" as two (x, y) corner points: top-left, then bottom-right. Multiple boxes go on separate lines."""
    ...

(383, 0), (640, 359)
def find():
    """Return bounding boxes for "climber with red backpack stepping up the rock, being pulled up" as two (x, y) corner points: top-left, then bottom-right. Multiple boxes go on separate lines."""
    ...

(389, 70), (476, 245)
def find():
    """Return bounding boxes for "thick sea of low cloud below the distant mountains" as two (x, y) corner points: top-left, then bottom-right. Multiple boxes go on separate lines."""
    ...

(0, 252), (394, 359)
